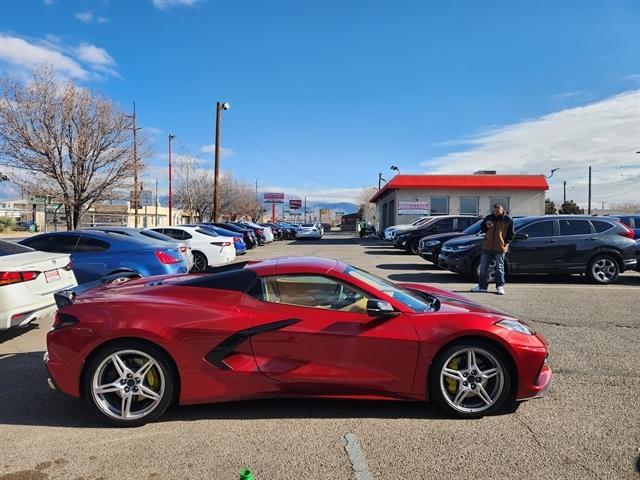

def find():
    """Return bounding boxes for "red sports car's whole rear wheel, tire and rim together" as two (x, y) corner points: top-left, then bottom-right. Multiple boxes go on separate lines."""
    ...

(84, 341), (175, 427)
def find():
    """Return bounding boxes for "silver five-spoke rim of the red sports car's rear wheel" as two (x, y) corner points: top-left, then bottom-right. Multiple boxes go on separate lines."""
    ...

(91, 350), (165, 420)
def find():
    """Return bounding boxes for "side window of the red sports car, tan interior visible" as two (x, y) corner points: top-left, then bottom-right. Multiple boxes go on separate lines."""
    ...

(261, 275), (370, 313)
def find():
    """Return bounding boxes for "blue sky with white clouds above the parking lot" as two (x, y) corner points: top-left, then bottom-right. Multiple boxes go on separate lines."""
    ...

(0, 0), (640, 206)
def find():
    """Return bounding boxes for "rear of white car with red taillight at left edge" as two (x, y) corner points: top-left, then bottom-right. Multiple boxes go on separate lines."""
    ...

(0, 240), (78, 330)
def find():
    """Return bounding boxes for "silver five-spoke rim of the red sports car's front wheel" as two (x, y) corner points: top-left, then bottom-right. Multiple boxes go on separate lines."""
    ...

(440, 347), (505, 413)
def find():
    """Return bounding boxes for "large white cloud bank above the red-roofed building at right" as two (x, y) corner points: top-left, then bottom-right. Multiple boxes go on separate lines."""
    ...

(422, 90), (640, 205)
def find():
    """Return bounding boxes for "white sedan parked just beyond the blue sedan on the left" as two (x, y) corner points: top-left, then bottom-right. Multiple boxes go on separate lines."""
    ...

(149, 225), (236, 273)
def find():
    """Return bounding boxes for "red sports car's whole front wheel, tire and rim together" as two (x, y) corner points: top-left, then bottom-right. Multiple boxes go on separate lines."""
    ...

(429, 341), (511, 418)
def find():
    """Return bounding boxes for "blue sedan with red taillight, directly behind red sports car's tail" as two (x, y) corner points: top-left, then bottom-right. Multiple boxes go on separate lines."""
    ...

(19, 230), (187, 284)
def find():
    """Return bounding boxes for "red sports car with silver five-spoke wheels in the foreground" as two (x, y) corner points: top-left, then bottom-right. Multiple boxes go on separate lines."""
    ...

(45, 257), (551, 426)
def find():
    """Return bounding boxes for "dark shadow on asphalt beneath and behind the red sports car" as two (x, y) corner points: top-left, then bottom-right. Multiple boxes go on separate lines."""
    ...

(0, 352), (460, 428)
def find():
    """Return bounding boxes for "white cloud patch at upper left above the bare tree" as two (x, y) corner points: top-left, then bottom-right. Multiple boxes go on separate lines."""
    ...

(0, 33), (119, 80)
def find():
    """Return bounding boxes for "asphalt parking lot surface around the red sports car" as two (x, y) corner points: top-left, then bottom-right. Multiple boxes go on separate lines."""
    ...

(0, 233), (640, 480)
